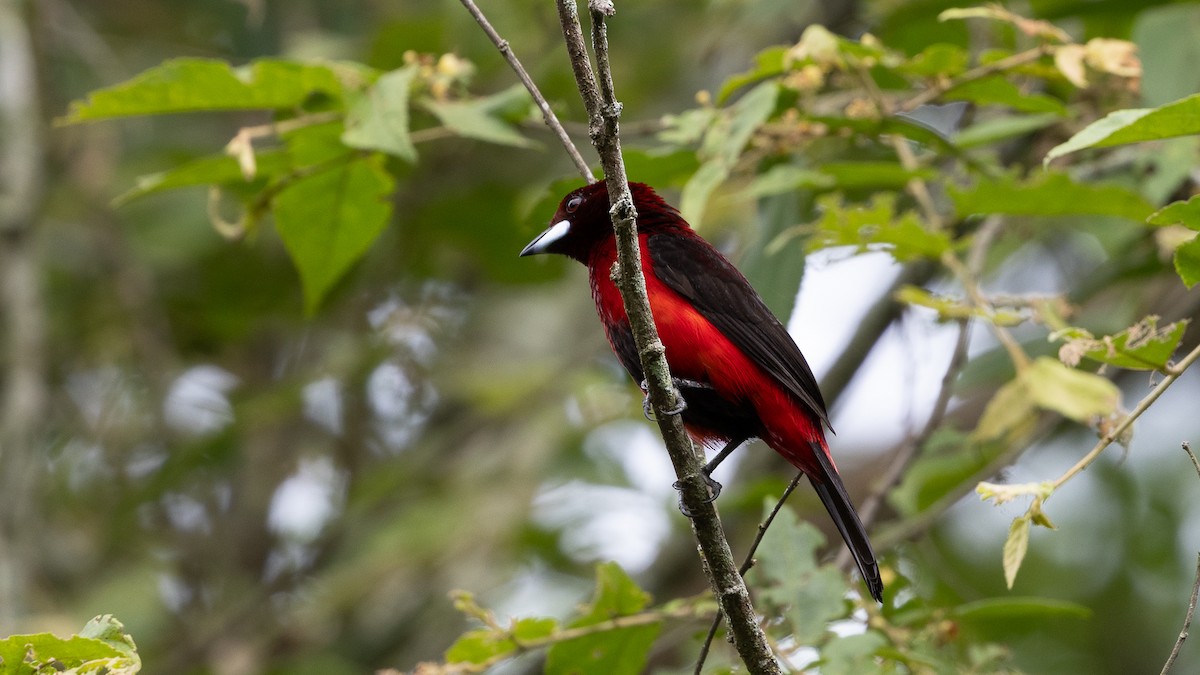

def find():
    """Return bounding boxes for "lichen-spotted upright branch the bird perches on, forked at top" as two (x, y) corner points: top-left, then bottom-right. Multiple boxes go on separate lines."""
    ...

(557, 0), (780, 674)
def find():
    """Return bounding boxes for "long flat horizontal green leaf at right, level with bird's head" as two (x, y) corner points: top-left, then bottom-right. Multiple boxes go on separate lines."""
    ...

(949, 172), (1154, 222)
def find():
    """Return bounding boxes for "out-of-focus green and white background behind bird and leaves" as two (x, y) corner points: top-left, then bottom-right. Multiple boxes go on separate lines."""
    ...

(0, 0), (1200, 675)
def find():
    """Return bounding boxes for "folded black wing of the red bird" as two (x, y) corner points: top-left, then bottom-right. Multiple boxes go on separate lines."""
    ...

(647, 234), (829, 426)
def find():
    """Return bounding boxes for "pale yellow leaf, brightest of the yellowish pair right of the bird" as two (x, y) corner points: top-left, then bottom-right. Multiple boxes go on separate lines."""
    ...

(1020, 357), (1121, 424)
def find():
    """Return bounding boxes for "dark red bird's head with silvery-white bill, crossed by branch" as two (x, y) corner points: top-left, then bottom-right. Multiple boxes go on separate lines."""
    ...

(521, 180), (686, 264)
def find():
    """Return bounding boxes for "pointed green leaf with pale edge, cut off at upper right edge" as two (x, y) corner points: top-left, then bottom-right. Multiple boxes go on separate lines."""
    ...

(1045, 94), (1200, 163)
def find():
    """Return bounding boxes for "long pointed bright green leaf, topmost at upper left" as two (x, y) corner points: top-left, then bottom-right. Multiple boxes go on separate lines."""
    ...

(61, 59), (343, 124)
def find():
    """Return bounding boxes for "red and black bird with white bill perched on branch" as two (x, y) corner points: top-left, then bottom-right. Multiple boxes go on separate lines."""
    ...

(521, 181), (883, 601)
